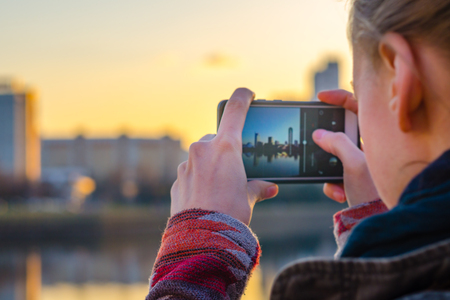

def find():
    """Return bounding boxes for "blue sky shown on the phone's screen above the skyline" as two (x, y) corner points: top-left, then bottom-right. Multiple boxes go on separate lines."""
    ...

(242, 107), (300, 145)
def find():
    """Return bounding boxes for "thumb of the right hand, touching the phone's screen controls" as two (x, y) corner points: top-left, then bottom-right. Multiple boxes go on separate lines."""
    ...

(313, 129), (364, 166)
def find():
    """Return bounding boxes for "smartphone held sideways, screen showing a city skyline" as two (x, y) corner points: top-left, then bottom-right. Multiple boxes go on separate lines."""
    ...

(217, 100), (359, 183)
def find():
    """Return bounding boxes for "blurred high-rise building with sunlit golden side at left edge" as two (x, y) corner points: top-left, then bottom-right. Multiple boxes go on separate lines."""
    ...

(0, 81), (40, 181)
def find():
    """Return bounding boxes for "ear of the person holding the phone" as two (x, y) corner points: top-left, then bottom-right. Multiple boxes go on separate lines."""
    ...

(378, 32), (423, 132)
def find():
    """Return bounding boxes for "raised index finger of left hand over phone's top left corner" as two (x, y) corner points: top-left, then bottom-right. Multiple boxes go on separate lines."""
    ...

(217, 88), (255, 141)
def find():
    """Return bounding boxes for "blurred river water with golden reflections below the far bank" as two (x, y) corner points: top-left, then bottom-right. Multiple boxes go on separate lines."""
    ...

(0, 205), (335, 300)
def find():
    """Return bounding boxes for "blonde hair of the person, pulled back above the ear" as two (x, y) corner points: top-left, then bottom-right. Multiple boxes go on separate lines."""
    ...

(348, 0), (450, 60)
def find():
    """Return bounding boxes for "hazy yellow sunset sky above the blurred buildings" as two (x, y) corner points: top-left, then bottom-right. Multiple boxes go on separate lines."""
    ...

(0, 0), (351, 148)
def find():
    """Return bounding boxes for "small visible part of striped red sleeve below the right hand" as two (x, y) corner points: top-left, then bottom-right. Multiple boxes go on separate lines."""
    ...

(333, 199), (388, 257)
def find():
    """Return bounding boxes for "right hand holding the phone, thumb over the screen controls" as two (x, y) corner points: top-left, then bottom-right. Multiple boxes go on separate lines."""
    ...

(313, 90), (379, 206)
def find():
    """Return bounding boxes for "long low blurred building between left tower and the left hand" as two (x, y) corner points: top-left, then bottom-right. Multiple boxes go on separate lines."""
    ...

(42, 136), (187, 182)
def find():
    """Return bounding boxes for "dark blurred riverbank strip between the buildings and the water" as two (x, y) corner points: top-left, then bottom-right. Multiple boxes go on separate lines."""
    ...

(0, 204), (341, 243)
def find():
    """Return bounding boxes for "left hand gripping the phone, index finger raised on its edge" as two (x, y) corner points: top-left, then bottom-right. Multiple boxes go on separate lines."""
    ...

(170, 88), (278, 225)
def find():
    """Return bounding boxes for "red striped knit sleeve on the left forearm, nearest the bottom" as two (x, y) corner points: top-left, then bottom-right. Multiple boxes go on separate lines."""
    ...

(146, 209), (261, 300)
